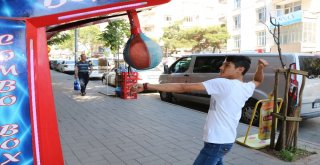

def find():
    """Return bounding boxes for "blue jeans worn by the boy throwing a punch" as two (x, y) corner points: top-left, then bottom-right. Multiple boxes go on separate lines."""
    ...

(193, 142), (233, 165)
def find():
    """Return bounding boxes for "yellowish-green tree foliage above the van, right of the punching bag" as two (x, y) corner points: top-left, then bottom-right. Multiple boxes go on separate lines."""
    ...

(162, 22), (229, 53)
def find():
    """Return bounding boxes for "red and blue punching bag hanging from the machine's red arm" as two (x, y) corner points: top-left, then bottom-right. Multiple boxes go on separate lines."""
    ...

(123, 10), (162, 70)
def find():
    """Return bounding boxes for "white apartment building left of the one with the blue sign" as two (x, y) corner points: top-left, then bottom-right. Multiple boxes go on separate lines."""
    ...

(226, 0), (273, 52)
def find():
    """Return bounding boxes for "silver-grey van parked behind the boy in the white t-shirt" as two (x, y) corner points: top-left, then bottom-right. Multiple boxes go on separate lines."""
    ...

(159, 53), (320, 124)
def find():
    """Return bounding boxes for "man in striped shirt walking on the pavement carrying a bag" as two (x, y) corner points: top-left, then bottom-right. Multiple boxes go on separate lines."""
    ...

(74, 54), (92, 96)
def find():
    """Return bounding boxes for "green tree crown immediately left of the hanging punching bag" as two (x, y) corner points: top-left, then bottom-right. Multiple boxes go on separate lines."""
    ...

(100, 20), (131, 54)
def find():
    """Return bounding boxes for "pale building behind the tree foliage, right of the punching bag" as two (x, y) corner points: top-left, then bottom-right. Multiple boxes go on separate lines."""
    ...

(139, 0), (226, 45)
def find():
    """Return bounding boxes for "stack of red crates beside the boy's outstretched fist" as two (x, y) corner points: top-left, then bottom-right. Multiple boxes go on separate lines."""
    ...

(120, 72), (138, 99)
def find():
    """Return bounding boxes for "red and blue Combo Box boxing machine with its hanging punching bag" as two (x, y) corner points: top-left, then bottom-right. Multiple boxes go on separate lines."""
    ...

(0, 0), (170, 165)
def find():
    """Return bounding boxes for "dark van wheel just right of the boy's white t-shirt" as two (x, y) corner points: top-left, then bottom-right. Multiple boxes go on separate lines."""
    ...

(241, 98), (260, 126)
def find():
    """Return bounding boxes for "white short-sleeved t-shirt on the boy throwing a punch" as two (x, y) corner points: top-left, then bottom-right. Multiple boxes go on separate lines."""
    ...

(203, 78), (256, 144)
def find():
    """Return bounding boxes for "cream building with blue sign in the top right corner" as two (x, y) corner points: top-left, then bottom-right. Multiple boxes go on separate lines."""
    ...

(271, 0), (320, 53)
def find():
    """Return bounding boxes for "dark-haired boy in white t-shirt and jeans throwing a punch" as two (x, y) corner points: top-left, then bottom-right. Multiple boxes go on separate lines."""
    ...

(131, 56), (268, 165)
